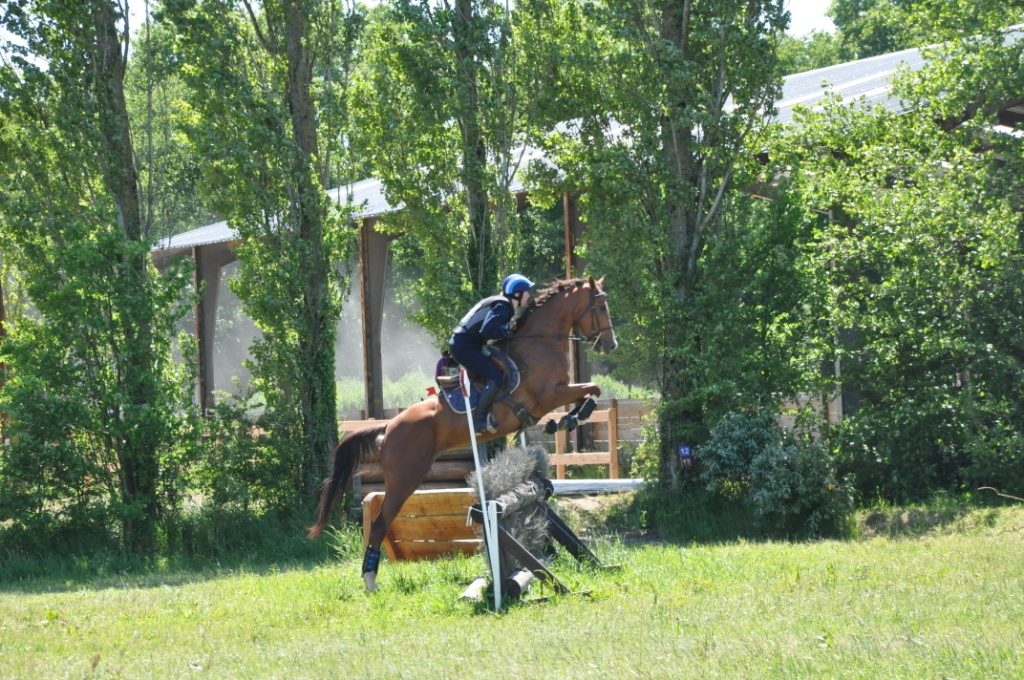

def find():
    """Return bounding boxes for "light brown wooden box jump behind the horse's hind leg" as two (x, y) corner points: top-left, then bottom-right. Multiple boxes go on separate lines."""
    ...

(362, 488), (480, 560)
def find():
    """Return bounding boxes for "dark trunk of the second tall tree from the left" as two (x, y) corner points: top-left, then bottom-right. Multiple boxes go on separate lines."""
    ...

(285, 0), (338, 500)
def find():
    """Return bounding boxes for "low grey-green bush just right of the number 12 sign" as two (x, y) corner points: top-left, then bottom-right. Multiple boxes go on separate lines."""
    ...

(697, 412), (853, 536)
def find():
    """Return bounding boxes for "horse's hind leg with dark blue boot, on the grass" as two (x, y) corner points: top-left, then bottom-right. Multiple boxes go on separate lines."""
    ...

(362, 441), (433, 592)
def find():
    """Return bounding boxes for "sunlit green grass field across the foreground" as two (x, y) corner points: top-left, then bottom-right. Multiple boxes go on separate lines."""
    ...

(0, 501), (1024, 679)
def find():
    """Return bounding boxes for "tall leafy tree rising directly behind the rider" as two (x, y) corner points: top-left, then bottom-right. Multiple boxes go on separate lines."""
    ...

(353, 0), (563, 339)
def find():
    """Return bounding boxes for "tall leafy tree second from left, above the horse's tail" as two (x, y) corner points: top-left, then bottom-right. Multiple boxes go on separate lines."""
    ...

(165, 0), (359, 499)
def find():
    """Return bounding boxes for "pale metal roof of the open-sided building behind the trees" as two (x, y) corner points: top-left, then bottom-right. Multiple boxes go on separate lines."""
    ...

(154, 39), (958, 255)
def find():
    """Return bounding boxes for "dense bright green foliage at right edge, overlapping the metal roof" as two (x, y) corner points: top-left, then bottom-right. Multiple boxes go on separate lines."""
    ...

(774, 15), (1024, 498)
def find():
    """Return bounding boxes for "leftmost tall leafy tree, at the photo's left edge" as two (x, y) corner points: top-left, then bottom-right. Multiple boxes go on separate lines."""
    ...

(0, 0), (192, 554)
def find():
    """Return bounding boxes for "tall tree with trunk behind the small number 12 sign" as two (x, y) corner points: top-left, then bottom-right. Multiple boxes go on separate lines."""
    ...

(553, 0), (786, 481)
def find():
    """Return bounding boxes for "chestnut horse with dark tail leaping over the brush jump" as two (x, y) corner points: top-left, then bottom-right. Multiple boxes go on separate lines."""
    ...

(307, 277), (618, 592)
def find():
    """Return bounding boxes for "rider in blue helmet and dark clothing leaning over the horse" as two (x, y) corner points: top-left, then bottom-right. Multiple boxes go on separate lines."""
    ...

(449, 273), (534, 430)
